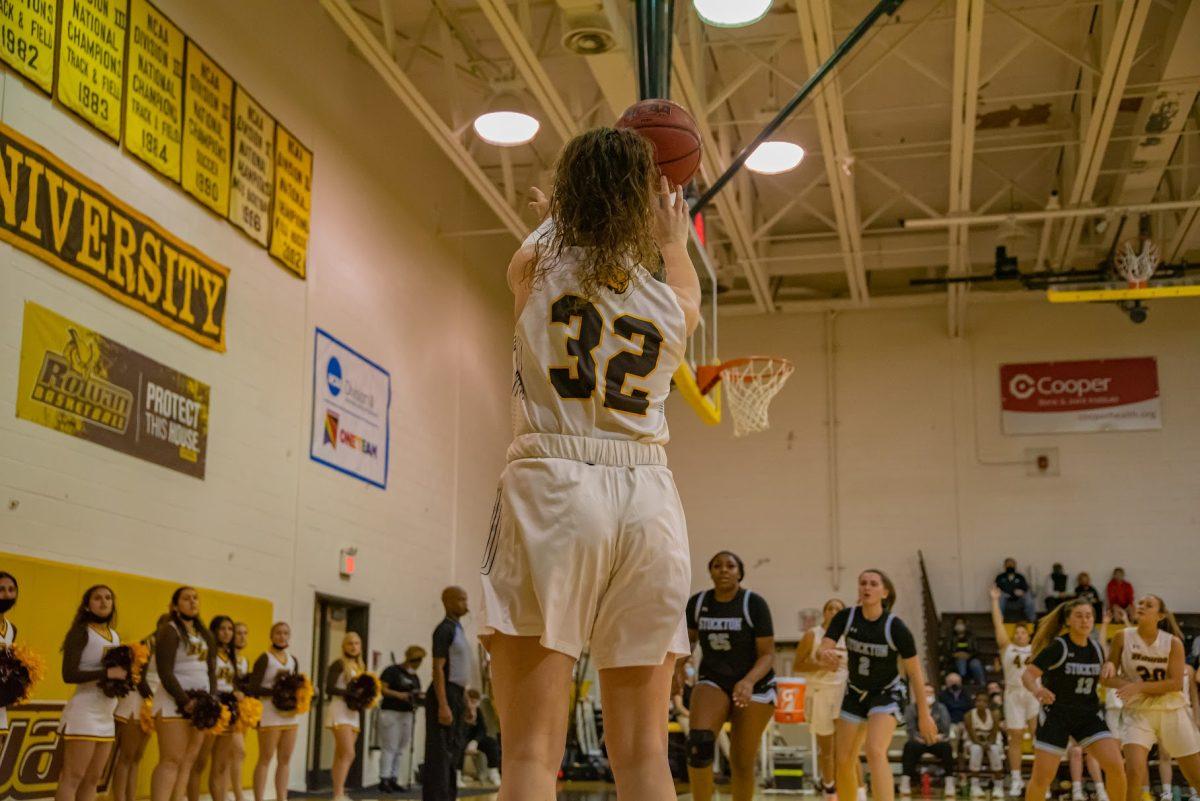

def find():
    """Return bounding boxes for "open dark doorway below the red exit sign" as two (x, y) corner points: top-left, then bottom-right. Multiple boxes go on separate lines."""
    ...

(305, 594), (371, 793)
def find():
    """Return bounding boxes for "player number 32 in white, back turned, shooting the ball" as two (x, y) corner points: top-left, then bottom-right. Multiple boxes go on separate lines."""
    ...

(481, 128), (700, 801)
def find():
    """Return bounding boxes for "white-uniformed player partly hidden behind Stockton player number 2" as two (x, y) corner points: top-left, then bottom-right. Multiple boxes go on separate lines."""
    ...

(796, 598), (850, 801)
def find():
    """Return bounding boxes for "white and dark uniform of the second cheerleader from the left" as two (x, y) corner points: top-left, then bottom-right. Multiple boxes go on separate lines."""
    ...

(59, 626), (121, 741)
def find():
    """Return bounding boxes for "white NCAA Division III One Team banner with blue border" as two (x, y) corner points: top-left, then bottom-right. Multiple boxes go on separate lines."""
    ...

(310, 329), (391, 489)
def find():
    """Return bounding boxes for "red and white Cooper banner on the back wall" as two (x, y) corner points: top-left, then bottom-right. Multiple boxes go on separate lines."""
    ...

(1000, 357), (1163, 434)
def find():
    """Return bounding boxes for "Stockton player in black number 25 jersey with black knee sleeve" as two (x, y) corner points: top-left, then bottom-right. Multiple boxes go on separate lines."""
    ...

(677, 550), (775, 801)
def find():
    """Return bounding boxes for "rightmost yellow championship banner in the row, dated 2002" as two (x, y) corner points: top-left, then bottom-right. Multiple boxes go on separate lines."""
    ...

(271, 125), (312, 278)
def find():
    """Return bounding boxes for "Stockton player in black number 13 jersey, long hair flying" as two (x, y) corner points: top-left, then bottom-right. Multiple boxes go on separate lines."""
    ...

(1021, 598), (1126, 801)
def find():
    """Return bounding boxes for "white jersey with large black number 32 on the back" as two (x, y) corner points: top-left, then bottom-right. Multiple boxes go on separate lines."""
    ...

(512, 221), (686, 445)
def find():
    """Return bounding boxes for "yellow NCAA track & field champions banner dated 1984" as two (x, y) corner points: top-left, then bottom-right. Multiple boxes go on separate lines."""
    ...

(125, 0), (184, 182)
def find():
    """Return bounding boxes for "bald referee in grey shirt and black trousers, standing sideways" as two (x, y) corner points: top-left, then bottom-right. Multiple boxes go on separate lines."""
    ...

(421, 586), (470, 801)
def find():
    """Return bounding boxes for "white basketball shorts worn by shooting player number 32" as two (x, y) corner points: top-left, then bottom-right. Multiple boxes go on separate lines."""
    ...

(480, 434), (691, 670)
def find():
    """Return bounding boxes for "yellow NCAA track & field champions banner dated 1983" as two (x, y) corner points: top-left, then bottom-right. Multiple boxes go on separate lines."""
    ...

(56, 0), (130, 141)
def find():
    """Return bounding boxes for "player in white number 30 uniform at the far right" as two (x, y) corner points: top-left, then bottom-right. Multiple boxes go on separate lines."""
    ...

(1100, 595), (1200, 799)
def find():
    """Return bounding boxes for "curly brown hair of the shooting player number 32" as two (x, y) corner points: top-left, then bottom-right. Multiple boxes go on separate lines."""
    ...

(529, 128), (659, 297)
